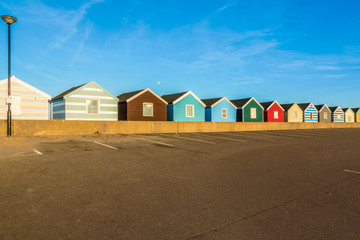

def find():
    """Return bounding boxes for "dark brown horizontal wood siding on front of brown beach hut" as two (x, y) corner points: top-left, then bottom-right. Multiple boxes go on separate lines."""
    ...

(127, 91), (167, 121)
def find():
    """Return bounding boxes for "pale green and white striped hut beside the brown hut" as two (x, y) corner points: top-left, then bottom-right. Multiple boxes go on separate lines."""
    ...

(50, 81), (118, 121)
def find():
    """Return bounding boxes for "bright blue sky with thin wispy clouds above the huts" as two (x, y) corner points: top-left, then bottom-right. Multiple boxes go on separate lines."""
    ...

(0, 0), (360, 107)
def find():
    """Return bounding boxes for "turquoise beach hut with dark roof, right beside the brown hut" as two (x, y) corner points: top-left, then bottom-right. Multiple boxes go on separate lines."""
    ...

(161, 91), (205, 122)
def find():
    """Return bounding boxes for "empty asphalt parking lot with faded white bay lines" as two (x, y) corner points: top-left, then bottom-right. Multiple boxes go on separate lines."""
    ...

(0, 129), (360, 240)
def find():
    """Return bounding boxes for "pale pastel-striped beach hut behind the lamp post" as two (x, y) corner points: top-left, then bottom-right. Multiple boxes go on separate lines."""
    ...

(0, 76), (51, 120)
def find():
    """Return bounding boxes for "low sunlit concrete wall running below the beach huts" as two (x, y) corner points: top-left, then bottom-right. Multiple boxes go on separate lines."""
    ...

(0, 120), (360, 136)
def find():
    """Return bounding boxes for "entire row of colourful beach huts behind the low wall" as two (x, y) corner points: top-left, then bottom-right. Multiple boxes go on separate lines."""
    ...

(0, 76), (360, 122)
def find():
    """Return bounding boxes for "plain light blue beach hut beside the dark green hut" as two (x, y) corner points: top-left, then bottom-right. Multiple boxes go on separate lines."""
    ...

(201, 97), (236, 122)
